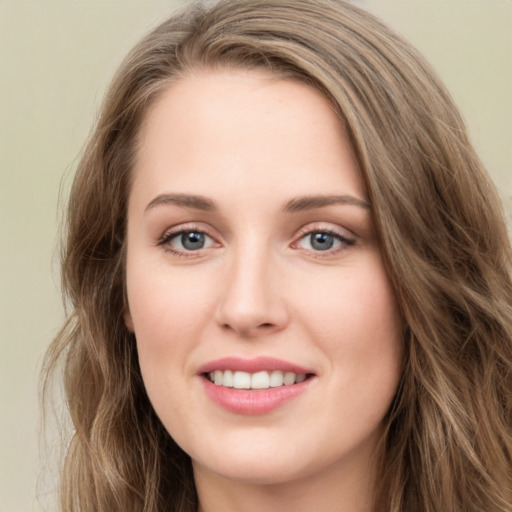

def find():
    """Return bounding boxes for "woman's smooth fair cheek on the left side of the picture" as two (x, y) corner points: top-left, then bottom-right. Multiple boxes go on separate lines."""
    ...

(127, 260), (222, 412)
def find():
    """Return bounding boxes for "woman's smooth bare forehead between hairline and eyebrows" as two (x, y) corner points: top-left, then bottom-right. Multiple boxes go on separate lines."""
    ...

(134, 70), (365, 210)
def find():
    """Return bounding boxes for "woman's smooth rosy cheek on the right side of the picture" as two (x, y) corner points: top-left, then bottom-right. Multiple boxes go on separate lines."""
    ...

(296, 264), (403, 408)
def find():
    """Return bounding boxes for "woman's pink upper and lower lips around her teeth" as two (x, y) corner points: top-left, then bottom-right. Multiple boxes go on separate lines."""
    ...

(198, 357), (316, 415)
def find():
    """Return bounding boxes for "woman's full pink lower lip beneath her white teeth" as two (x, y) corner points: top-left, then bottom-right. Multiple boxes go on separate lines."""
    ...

(201, 377), (314, 415)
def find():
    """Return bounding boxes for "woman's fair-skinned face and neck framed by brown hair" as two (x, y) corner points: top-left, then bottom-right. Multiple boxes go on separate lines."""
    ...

(126, 70), (402, 512)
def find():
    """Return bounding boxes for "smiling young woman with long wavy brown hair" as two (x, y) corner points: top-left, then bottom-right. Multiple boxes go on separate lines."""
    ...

(47, 0), (512, 512)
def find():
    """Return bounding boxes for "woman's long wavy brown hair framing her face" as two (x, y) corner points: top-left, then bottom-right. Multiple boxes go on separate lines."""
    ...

(45, 0), (512, 512)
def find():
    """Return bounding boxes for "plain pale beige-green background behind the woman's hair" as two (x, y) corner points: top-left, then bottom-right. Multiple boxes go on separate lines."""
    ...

(0, 0), (512, 512)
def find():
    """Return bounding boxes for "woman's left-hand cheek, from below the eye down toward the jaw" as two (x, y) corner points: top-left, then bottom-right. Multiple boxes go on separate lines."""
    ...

(127, 268), (208, 432)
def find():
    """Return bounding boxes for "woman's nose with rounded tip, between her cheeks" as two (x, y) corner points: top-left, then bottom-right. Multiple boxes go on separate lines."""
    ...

(216, 246), (289, 339)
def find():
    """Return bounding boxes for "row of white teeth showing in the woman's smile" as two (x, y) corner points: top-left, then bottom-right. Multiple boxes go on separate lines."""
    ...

(209, 370), (306, 389)
